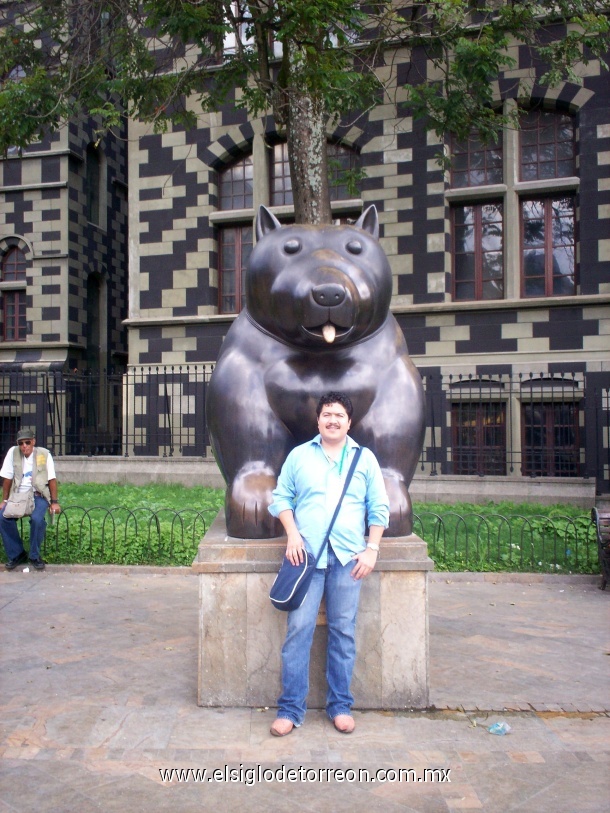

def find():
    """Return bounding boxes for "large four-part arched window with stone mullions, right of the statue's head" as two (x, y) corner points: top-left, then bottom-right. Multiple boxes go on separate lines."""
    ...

(447, 102), (579, 301)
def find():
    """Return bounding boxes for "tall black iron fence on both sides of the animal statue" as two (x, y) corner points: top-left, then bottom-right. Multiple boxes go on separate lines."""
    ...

(0, 364), (610, 494)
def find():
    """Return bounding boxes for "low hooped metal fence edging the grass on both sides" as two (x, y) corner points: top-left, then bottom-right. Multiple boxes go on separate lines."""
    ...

(1, 505), (599, 574)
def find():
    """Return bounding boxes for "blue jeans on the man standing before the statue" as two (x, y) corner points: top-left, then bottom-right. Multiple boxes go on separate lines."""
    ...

(277, 547), (362, 726)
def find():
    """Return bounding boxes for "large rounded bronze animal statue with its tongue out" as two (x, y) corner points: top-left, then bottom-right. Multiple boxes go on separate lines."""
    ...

(207, 206), (424, 539)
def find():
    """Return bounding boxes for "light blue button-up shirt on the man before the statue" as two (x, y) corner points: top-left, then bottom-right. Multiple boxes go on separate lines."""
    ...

(269, 435), (390, 567)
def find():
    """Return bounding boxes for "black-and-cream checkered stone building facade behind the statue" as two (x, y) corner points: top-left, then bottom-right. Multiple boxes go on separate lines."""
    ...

(0, 22), (610, 493)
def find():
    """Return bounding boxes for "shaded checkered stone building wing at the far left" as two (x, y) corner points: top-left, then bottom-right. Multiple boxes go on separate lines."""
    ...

(0, 120), (128, 453)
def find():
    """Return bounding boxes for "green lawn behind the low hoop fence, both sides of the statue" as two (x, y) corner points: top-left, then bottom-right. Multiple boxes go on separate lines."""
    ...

(24, 484), (599, 573)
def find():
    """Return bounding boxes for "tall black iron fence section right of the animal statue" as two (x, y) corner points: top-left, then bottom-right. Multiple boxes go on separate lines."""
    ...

(421, 371), (610, 493)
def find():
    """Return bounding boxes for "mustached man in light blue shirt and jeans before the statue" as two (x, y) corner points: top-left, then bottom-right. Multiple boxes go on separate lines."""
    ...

(269, 392), (389, 737)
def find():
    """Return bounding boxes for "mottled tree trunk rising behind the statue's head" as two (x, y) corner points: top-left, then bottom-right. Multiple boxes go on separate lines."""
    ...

(286, 88), (332, 224)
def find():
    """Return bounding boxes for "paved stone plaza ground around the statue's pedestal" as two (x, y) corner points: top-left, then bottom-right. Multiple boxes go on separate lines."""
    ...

(0, 566), (610, 813)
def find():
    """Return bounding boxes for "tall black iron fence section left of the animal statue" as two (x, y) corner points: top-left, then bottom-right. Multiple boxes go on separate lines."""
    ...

(0, 364), (213, 457)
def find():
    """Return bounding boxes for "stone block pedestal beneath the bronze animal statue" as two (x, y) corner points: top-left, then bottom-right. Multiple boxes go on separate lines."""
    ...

(193, 512), (433, 710)
